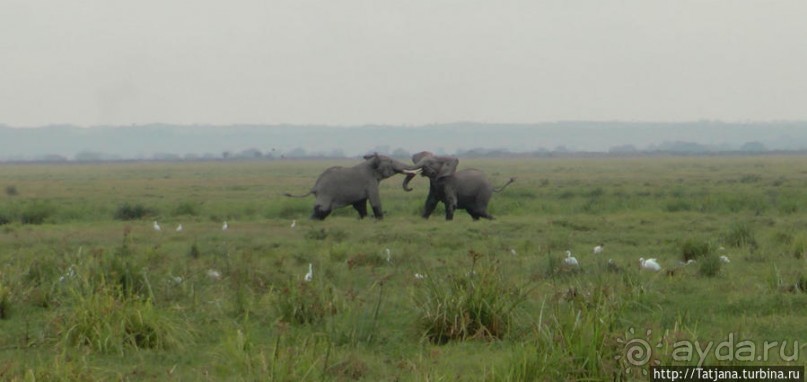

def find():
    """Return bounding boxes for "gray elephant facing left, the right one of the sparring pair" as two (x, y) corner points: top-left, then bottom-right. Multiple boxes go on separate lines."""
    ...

(403, 151), (515, 220)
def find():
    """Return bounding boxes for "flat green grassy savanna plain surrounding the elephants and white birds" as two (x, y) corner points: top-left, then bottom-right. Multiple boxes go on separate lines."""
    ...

(0, 155), (807, 381)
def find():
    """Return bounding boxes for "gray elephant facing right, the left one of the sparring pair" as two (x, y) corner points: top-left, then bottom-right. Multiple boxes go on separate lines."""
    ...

(284, 153), (415, 220)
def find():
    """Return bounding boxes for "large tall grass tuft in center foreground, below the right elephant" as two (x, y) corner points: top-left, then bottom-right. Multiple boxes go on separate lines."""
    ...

(415, 250), (526, 344)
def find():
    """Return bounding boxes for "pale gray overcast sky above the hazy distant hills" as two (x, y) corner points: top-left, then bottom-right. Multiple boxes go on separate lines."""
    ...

(0, 0), (807, 126)
